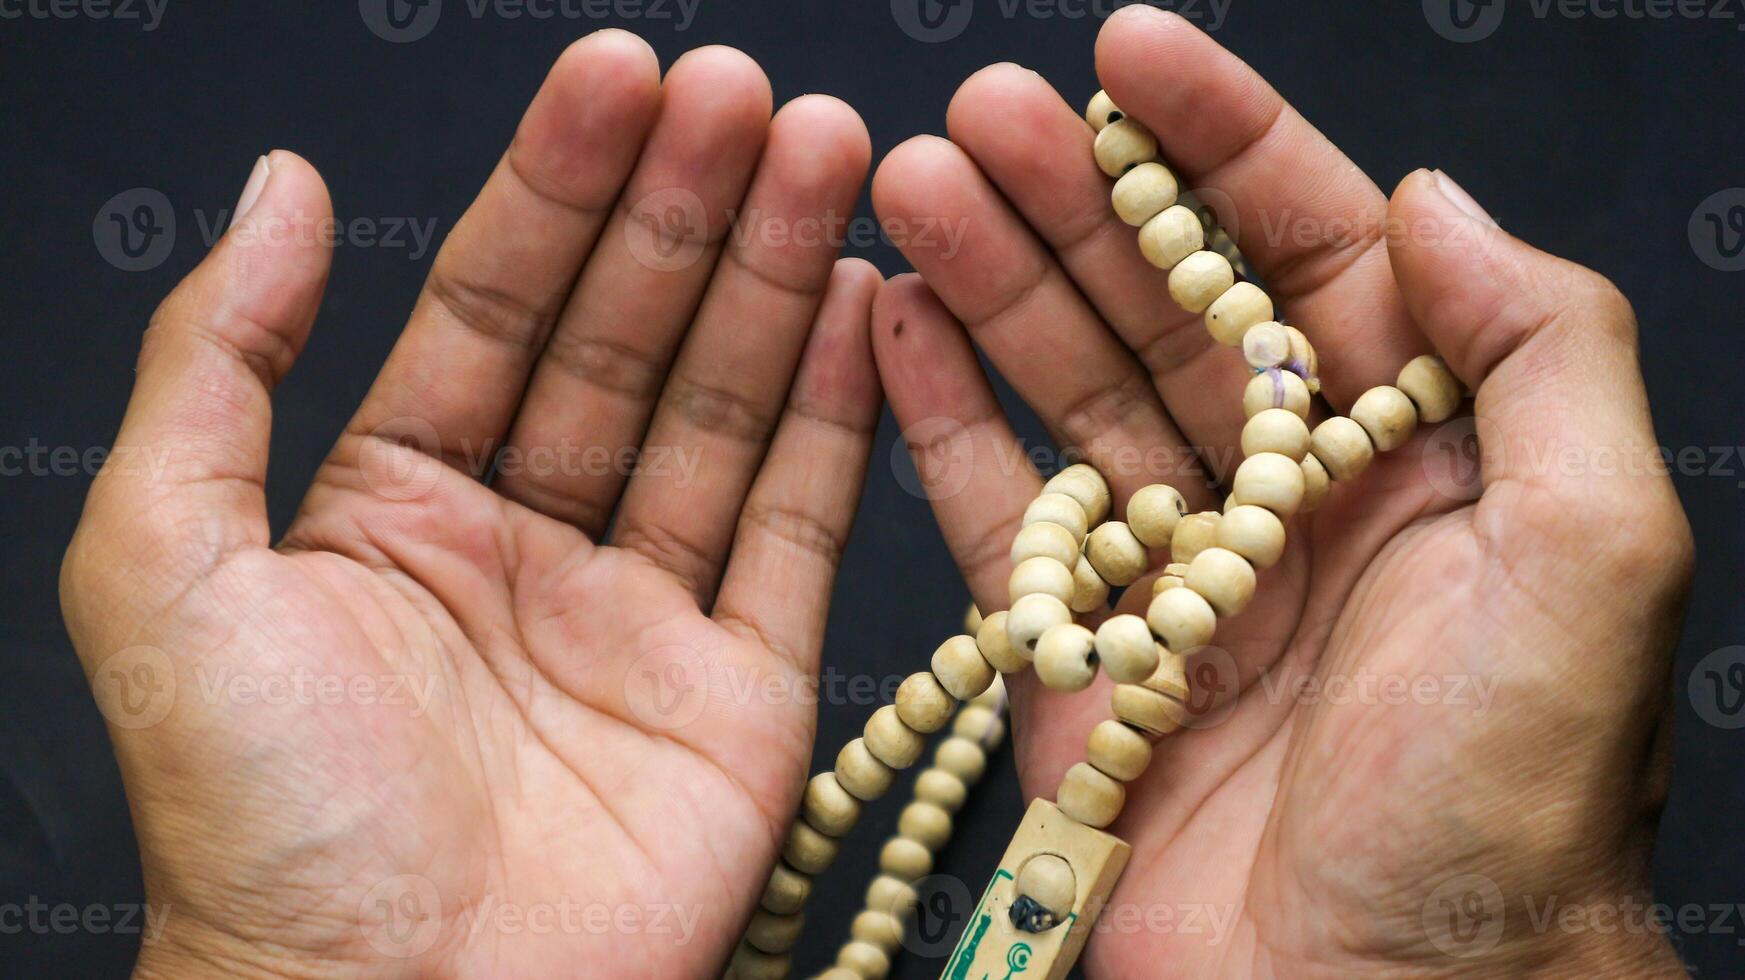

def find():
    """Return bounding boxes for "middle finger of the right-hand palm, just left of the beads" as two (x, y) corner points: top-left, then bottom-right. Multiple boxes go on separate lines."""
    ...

(946, 65), (1246, 456)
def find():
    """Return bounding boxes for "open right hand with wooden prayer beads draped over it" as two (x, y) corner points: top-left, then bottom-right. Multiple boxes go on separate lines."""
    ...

(874, 7), (1691, 977)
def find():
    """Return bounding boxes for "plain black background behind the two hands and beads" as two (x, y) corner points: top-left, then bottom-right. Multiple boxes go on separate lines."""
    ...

(0, 0), (1745, 977)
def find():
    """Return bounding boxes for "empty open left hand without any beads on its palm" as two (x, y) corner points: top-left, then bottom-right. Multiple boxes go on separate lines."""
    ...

(63, 31), (879, 977)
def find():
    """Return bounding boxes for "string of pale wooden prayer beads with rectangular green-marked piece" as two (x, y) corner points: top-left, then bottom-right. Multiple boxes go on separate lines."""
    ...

(728, 92), (1464, 980)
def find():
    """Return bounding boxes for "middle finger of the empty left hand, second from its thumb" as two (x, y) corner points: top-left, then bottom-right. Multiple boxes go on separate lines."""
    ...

(496, 47), (770, 541)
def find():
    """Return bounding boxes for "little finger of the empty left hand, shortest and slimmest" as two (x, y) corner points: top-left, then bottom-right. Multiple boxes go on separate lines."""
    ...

(715, 258), (883, 659)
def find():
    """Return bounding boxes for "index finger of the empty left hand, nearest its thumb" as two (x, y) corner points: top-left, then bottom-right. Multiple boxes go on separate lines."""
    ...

(330, 30), (660, 476)
